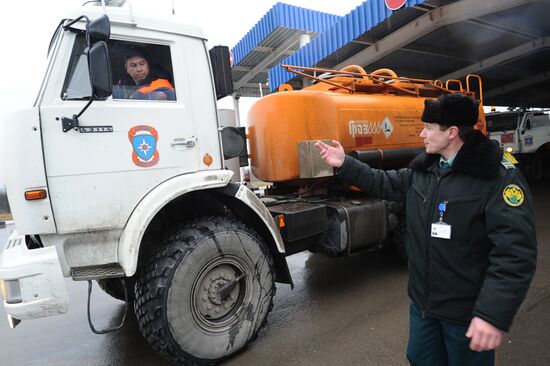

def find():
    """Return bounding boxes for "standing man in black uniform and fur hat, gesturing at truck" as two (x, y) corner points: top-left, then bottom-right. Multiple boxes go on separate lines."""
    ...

(316, 93), (536, 366)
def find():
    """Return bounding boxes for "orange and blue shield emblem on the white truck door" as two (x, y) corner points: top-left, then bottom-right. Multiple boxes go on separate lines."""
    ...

(128, 125), (159, 168)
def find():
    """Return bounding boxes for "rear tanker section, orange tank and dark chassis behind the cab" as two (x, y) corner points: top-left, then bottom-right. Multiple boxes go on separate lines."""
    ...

(248, 65), (485, 256)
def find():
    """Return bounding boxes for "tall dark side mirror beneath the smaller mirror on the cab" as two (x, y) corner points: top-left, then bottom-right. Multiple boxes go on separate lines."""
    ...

(88, 41), (113, 99)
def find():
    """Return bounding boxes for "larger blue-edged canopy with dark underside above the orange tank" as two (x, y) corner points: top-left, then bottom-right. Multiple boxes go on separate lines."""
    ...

(258, 0), (550, 107)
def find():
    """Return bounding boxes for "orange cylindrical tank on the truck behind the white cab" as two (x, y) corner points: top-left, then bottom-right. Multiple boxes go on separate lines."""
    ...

(248, 66), (485, 182)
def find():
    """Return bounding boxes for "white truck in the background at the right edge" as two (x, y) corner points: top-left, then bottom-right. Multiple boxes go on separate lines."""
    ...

(485, 109), (550, 180)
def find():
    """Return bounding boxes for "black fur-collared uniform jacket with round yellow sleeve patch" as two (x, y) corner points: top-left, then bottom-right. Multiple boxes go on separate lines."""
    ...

(337, 131), (537, 331)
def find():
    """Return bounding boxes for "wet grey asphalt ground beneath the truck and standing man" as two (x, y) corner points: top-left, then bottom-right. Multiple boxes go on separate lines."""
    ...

(0, 180), (550, 366)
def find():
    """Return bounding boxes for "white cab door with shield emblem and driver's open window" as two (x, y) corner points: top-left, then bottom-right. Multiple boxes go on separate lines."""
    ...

(40, 32), (216, 233)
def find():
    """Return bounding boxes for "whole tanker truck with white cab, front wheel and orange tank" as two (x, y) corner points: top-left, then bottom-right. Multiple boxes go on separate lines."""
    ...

(0, 5), (485, 364)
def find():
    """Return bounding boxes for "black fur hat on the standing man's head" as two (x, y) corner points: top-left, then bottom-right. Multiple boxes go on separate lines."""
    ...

(420, 93), (479, 126)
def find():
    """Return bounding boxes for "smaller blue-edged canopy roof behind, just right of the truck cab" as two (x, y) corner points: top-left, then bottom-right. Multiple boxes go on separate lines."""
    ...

(231, 3), (340, 97)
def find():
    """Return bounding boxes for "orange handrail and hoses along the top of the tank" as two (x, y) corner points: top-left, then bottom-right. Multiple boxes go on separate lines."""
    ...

(281, 64), (481, 96)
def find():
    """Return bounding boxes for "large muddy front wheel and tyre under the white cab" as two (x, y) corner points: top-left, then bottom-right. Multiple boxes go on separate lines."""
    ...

(134, 218), (275, 365)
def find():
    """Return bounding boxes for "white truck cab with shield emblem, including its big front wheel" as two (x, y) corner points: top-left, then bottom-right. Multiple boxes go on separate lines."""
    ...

(0, 5), (291, 364)
